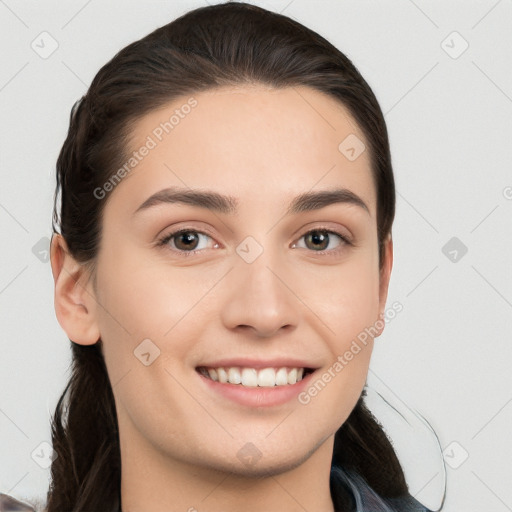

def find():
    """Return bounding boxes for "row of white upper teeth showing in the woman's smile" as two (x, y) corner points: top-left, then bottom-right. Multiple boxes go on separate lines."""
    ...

(200, 367), (304, 387)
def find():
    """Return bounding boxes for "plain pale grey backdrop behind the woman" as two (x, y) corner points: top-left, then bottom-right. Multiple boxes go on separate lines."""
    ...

(0, 0), (512, 512)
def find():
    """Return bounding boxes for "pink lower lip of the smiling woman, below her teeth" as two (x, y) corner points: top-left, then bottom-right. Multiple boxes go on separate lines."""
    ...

(196, 372), (314, 407)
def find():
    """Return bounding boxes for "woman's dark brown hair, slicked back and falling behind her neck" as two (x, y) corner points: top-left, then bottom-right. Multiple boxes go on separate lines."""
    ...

(47, 2), (407, 512)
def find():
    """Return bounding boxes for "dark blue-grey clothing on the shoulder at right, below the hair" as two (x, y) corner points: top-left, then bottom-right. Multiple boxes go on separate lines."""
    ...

(331, 465), (431, 512)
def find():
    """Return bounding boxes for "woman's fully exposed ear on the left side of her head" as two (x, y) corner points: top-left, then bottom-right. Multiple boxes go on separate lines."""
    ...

(50, 233), (100, 345)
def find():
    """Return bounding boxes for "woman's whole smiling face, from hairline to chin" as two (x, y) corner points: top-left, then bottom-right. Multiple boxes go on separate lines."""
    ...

(84, 86), (387, 474)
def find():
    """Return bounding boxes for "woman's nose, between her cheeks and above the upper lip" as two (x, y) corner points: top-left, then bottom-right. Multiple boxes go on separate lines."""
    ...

(221, 251), (301, 338)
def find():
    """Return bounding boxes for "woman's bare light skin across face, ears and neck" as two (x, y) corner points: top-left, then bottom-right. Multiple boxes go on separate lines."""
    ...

(51, 85), (392, 512)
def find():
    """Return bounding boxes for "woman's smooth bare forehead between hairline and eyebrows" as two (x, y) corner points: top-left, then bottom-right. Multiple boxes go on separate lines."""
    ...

(107, 85), (375, 216)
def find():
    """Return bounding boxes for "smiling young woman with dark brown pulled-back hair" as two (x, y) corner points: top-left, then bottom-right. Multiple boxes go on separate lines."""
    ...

(39, 2), (436, 512)
